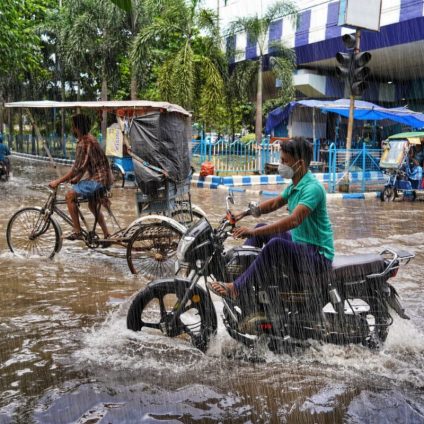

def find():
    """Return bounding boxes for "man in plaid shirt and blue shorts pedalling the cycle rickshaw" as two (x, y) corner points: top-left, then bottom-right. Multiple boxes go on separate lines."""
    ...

(49, 113), (113, 240)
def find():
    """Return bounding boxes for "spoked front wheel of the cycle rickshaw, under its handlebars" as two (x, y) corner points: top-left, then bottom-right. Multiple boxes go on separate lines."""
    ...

(6, 208), (62, 258)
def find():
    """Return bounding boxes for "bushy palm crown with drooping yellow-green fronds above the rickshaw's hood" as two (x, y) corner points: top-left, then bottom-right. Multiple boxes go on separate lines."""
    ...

(132, 0), (225, 117)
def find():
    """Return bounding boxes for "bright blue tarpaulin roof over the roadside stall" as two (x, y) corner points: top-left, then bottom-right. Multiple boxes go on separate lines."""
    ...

(265, 99), (424, 134)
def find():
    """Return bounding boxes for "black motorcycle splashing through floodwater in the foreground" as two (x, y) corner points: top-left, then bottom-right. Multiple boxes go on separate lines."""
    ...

(127, 196), (415, 352)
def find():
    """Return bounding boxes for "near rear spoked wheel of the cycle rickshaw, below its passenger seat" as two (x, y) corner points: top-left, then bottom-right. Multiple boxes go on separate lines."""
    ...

(127, 222), (182, 278)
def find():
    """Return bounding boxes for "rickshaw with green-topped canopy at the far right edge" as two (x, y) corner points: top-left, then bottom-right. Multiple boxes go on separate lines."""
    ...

(380, 131), (424, 202)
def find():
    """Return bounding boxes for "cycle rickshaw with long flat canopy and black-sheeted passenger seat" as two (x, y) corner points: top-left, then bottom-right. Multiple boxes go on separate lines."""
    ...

(6, 101), (205, 277)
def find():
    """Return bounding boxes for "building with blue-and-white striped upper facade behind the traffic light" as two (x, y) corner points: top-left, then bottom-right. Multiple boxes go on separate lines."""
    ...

(210, 0), (424, 111)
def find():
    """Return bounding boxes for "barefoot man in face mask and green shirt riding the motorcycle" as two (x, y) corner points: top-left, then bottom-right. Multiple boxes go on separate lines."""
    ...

(209, 138), (334, 303)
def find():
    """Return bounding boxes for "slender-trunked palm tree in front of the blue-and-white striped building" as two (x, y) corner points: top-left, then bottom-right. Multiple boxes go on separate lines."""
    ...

(228, 0), (298, 144)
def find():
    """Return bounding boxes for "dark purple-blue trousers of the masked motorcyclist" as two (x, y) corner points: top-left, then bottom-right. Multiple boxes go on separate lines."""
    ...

(234, 224), (331, 294)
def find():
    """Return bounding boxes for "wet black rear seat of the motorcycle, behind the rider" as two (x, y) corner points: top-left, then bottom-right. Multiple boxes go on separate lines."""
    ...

(332, 253), (385, 282)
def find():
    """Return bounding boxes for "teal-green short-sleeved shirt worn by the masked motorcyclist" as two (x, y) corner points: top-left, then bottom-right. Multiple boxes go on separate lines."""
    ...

(281, 171), (334, 260)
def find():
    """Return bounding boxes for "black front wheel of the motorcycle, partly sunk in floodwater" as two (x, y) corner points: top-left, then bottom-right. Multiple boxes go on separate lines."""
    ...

(127, 278), (217, 351)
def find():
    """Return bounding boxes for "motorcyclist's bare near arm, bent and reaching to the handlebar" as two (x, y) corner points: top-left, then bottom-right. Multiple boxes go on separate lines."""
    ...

(233, 205), (311, 238)
